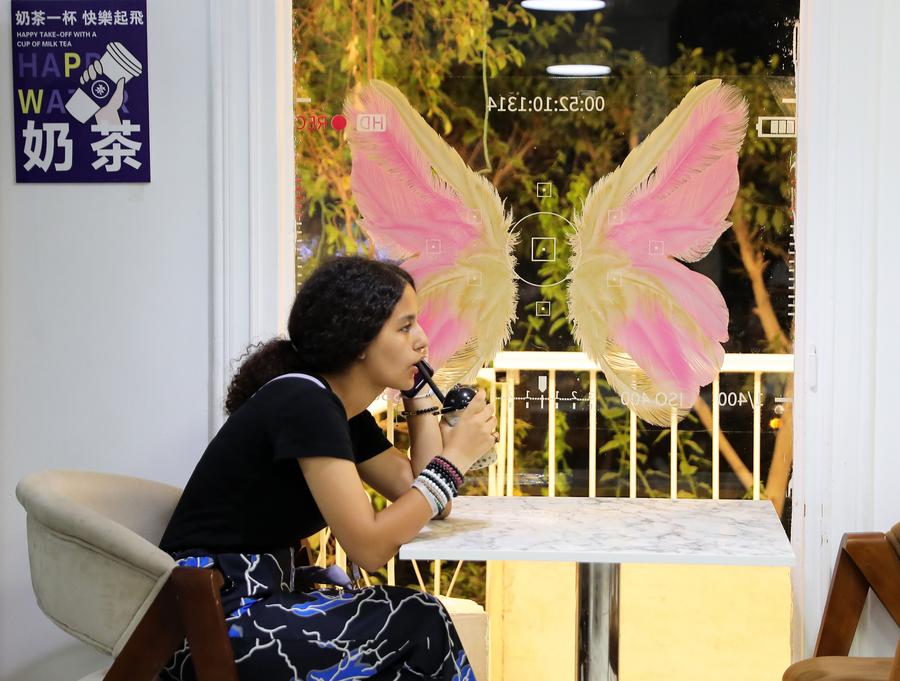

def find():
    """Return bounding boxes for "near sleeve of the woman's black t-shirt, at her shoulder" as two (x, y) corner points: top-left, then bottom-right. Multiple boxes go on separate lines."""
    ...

(265, 378), (356, 461)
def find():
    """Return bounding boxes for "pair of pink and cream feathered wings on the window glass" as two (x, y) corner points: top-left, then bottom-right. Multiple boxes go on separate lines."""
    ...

(344, 80), (747, 425)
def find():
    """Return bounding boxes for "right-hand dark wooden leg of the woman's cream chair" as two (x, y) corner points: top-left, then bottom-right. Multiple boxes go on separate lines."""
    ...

(169, 568), (238, 681)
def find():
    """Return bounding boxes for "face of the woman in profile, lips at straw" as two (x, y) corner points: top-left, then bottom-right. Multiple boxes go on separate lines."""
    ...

(362, 285), (428, 390)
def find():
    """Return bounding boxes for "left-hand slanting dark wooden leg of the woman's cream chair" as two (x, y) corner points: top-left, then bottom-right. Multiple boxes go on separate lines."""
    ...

(103, 580), (185, 681)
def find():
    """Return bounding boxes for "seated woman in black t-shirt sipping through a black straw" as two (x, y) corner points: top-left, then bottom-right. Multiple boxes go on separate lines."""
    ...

(160, 257), (496, 681)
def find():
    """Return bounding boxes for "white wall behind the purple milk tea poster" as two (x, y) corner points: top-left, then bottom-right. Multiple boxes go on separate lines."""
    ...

(0, 0), (293, 681)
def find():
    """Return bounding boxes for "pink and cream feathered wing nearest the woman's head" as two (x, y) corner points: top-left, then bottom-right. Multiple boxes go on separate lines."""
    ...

(345, 81), (515, 383)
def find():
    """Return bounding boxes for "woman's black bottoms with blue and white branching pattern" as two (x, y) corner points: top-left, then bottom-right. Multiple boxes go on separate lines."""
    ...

(160, 549), (475, 681)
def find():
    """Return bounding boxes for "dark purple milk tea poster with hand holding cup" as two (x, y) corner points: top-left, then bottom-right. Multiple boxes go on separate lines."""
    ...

(12, 0), (150, 182)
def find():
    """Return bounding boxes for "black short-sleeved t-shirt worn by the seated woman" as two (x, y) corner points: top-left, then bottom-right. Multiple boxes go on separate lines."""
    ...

(159, 376), (391, 553)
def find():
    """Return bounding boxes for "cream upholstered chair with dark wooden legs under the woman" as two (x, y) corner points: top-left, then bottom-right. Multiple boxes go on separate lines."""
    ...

(16, 470), (238, 681)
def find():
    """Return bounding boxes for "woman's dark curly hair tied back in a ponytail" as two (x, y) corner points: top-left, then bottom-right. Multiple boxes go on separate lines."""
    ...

(225, 256), (415, 414)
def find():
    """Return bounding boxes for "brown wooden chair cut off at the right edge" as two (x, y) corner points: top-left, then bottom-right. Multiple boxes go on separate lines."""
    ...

(783, 523), (900, 681)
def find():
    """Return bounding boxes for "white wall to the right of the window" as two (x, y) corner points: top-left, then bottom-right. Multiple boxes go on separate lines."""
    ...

(792, 0), (900, 656)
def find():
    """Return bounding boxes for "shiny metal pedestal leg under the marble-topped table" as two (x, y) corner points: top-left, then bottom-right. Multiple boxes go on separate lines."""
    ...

(576, 563), (619, 681)
